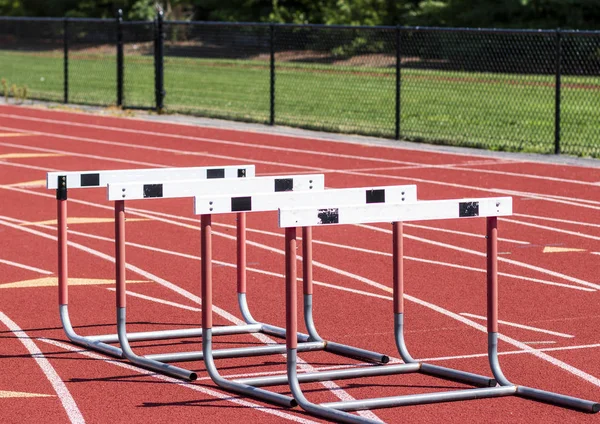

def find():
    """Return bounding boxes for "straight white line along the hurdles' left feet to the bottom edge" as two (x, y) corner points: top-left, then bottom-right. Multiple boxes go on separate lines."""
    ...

(38, 338), (316, 424)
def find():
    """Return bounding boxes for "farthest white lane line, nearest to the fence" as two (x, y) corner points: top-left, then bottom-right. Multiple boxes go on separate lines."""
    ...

(0, 113), (596, 186)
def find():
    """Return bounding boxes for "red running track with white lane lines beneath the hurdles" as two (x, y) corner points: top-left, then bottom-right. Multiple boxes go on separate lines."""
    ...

(0, 106), (600, 424)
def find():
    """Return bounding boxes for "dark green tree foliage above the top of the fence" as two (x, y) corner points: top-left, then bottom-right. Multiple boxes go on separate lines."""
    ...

(0, 0), (600, 29)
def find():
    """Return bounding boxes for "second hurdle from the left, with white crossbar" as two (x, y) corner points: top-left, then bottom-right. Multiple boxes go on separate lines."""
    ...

(107, 174), (325, 380)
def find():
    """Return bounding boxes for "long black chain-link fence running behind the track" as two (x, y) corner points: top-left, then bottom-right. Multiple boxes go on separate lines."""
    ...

(0, 17), (600, 157)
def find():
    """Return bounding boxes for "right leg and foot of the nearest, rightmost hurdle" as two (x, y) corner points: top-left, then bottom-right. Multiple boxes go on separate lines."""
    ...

(487, 217), (600, 413)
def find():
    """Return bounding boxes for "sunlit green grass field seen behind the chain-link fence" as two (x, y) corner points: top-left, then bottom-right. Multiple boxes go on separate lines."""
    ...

(0, 51), (600, 157)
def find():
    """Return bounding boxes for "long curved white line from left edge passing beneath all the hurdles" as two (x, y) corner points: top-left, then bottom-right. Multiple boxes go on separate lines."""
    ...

(0, 220), (380, 420)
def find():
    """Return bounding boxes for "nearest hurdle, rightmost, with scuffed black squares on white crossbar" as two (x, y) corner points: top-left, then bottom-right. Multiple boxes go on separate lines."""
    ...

(270, 197), (600, 423)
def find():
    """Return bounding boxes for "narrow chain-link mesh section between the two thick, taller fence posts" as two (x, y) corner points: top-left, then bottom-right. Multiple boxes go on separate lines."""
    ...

(122, 22), (155, 108)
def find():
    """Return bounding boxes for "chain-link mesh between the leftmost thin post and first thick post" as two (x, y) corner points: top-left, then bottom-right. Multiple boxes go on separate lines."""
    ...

(68, 19), (117, 106)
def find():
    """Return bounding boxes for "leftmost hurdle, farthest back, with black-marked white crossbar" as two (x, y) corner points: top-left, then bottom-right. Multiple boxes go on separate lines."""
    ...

(46, 165), (255, 358)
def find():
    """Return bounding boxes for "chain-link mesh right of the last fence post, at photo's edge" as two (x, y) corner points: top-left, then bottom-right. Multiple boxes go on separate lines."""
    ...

(561, 32), (600, 157)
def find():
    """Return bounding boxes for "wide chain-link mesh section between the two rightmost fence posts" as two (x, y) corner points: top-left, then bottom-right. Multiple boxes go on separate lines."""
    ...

(401, 29), (555, 153)
